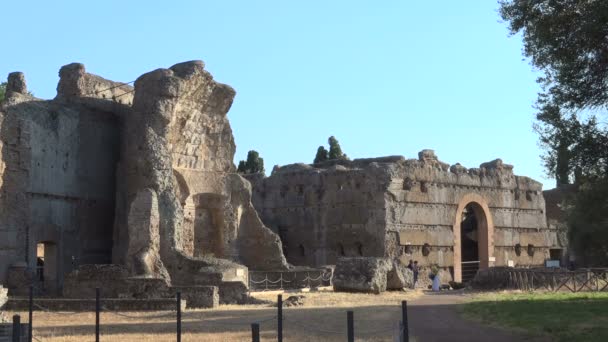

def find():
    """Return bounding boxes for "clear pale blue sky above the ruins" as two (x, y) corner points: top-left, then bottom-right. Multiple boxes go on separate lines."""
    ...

(0, 0), (554, 188)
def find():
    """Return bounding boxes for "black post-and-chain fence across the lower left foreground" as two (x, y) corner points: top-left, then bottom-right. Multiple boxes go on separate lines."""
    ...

(0, 287), (409, 342)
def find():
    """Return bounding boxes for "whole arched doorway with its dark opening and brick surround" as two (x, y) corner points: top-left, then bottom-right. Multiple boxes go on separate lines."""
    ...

(453, 194), (494, 282)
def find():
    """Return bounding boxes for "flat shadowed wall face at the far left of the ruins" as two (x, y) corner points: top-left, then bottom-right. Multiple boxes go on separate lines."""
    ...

(0, 73), (119, 291)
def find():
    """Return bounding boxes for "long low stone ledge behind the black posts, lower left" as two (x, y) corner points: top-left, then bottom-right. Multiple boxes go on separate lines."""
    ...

(6, 298), (187, 312)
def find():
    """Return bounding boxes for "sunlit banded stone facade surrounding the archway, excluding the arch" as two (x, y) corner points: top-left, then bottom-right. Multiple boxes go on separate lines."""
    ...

(387, 150), (557, 267)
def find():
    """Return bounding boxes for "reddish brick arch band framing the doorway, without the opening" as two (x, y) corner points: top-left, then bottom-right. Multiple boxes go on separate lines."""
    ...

(453, 193), (494, 282)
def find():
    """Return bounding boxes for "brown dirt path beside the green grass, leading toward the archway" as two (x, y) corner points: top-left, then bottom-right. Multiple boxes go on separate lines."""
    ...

(408, 292), (538, 342)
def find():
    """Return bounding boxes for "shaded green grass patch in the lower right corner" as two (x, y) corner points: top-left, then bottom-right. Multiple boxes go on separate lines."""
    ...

(462, 292), (608, 342)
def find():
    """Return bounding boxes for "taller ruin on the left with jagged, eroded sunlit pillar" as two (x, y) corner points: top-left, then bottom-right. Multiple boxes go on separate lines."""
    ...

(0, 61), (289, 304)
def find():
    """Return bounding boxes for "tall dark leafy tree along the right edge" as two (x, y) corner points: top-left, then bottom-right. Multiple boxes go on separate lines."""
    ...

(500, 0), (608, 265)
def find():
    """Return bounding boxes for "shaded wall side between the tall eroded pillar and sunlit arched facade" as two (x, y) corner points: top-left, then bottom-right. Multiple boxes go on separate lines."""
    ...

(253, 158), (398, 266)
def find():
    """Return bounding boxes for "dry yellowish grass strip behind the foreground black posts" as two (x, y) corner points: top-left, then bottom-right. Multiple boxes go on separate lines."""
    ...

(10, 291), (419, 342)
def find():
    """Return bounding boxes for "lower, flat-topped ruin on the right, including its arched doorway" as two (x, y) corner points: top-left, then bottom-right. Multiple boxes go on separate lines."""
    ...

(249, 150), (561, 283)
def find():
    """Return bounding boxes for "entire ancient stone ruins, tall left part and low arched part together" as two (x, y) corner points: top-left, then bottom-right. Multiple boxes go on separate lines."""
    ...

(0, 61), (561, 306)
